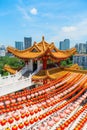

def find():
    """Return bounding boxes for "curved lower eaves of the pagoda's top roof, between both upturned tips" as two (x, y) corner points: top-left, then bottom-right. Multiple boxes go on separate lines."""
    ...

(7, 47), (76, 59)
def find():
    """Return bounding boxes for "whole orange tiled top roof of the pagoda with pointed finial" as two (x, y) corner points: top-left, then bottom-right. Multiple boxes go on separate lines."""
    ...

(7, 37), (76, 59)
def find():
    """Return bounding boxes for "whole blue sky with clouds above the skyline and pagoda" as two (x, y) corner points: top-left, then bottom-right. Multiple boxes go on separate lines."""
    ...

(0, 0), (87, 47)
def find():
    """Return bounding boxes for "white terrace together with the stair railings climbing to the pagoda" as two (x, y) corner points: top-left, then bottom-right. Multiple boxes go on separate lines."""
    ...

(0, 63), (42, 96)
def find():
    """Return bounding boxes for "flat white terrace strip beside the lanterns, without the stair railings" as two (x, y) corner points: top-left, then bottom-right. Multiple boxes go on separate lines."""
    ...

(0, 75), (33, 96)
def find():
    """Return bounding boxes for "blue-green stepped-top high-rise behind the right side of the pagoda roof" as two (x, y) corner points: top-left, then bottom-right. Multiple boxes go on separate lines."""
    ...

(59, 39), (70, 50)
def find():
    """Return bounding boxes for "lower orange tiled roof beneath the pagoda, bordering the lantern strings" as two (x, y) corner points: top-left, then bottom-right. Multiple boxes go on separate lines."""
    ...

(32, 64), (87, 80)
